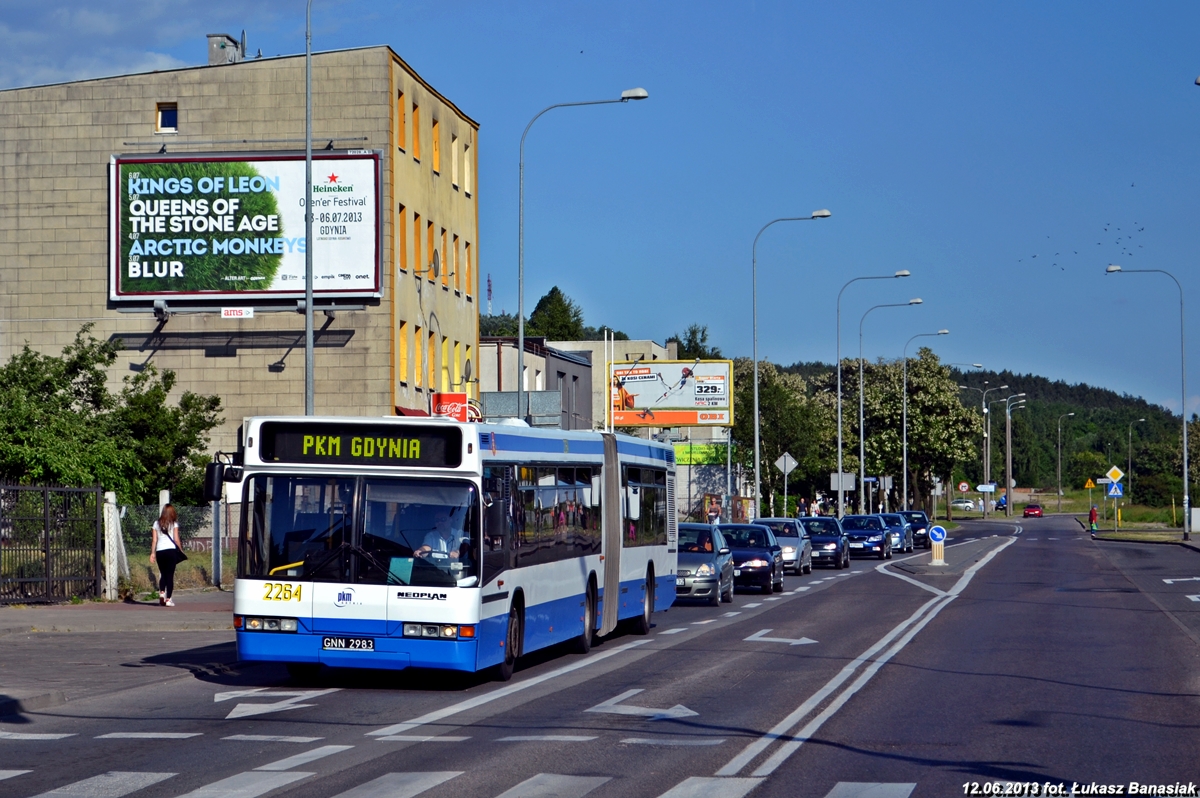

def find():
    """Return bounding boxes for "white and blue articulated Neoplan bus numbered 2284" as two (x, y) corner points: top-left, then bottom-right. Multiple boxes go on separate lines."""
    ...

(223, 416), (677, 679)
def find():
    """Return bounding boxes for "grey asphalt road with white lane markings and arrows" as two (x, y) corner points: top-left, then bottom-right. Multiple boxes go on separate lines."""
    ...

(0, 517), (1200, 798)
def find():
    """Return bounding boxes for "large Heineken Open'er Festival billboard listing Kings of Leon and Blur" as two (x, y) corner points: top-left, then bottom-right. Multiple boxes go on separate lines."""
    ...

(108, 150), (380, 301)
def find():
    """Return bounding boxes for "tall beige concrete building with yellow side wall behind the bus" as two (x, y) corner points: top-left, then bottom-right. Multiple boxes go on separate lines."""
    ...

(0, 35), (480, 451)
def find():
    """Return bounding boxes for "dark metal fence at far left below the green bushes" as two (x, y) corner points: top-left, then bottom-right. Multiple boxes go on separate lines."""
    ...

(0, 485), (104, 604)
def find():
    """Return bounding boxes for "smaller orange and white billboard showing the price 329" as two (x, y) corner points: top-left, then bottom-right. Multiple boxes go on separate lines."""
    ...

(608, 360), (733, 427)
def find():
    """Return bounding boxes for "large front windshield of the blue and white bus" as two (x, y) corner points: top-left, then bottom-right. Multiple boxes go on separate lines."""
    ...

(240, 475), (479, 587)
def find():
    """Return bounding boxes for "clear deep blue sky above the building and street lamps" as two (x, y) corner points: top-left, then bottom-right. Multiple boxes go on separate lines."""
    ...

(7, 0), (1200, 413)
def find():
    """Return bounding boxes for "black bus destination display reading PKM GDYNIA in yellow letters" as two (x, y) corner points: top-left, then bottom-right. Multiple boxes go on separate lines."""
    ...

(259, 422), (462, 468)
